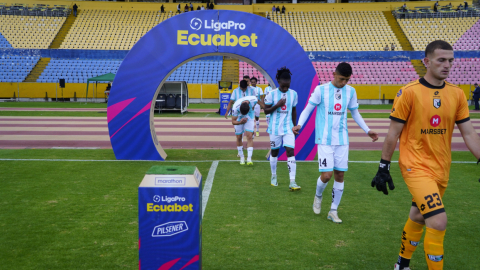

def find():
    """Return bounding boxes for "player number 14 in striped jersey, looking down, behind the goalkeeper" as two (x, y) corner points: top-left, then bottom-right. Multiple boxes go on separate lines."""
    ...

(293, 62), (378, 223)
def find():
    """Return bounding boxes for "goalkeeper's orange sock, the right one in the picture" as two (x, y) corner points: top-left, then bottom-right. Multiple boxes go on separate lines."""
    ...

(423, 227), (445, 270)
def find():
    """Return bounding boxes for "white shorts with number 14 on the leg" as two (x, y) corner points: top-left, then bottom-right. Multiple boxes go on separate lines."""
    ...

(317, 144), (348, 172)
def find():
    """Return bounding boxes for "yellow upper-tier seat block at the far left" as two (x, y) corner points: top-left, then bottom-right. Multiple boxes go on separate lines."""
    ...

(0, 15), (65, 49)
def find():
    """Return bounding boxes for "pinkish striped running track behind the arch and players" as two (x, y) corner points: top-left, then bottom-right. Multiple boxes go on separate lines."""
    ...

(0, 116), (480, 151)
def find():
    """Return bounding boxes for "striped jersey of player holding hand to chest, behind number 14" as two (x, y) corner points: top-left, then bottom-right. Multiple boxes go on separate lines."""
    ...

(265, 89), (298, 135)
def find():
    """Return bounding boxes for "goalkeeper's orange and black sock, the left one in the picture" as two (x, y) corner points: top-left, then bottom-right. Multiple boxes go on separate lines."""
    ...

(398, 218), (424, 269)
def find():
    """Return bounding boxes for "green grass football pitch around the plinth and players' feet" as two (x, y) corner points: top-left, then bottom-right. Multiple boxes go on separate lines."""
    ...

(0, 149), (480, 269)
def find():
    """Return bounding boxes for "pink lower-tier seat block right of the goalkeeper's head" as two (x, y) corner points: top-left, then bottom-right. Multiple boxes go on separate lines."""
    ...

(447, 58), (480, 84)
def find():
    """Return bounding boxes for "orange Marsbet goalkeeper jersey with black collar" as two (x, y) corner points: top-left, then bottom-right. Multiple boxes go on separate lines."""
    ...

(390, 78), (470, 181)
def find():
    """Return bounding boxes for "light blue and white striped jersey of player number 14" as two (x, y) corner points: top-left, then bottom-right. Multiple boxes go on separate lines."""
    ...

(308, 82), (358, 145)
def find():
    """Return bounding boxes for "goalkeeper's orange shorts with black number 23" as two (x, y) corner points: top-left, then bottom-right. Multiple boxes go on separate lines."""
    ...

(404, 177), (448, 219)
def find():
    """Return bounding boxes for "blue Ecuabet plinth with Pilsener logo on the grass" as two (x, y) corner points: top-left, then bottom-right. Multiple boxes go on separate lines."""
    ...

(138, 166), (202, 270)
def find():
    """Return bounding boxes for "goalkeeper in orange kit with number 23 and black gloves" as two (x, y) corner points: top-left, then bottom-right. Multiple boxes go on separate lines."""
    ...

(372, 40), (480, 270)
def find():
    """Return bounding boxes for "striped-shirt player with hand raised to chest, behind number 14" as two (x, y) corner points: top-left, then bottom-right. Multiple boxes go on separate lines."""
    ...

(264, 67), (301, 191)
